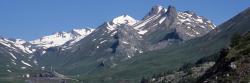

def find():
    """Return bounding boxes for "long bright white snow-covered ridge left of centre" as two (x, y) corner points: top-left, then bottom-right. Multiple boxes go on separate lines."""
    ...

(30, 28), (94, 49)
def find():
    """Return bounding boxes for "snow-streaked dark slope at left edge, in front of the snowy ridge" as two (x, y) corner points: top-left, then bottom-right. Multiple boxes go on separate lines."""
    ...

(0, 37), (37, 82)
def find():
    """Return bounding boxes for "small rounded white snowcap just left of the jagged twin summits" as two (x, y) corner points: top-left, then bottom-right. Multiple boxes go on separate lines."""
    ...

(112, 15), (137, 25)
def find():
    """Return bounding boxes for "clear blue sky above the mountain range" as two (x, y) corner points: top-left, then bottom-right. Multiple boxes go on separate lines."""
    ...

(0, 0), (250, 40)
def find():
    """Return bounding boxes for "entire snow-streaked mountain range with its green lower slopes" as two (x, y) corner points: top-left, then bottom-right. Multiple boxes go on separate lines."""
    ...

(0, 5), (246, 83)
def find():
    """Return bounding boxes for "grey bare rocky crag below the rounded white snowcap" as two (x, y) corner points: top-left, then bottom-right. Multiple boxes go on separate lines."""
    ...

(116, 25), (145, 58)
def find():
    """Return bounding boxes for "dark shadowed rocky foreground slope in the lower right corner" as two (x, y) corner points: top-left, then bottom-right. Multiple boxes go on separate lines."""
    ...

(198, 32), (250, 83)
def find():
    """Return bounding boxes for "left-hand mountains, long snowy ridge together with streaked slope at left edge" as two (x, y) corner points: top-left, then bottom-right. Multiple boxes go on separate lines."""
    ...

(0, 28), (94, 82)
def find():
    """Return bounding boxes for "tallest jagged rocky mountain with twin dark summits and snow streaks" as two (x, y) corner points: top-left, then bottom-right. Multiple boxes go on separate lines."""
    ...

(134, 6), (215, 50)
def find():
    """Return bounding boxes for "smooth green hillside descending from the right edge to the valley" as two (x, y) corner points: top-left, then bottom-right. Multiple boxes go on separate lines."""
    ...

(78, 8), (250, 82)
